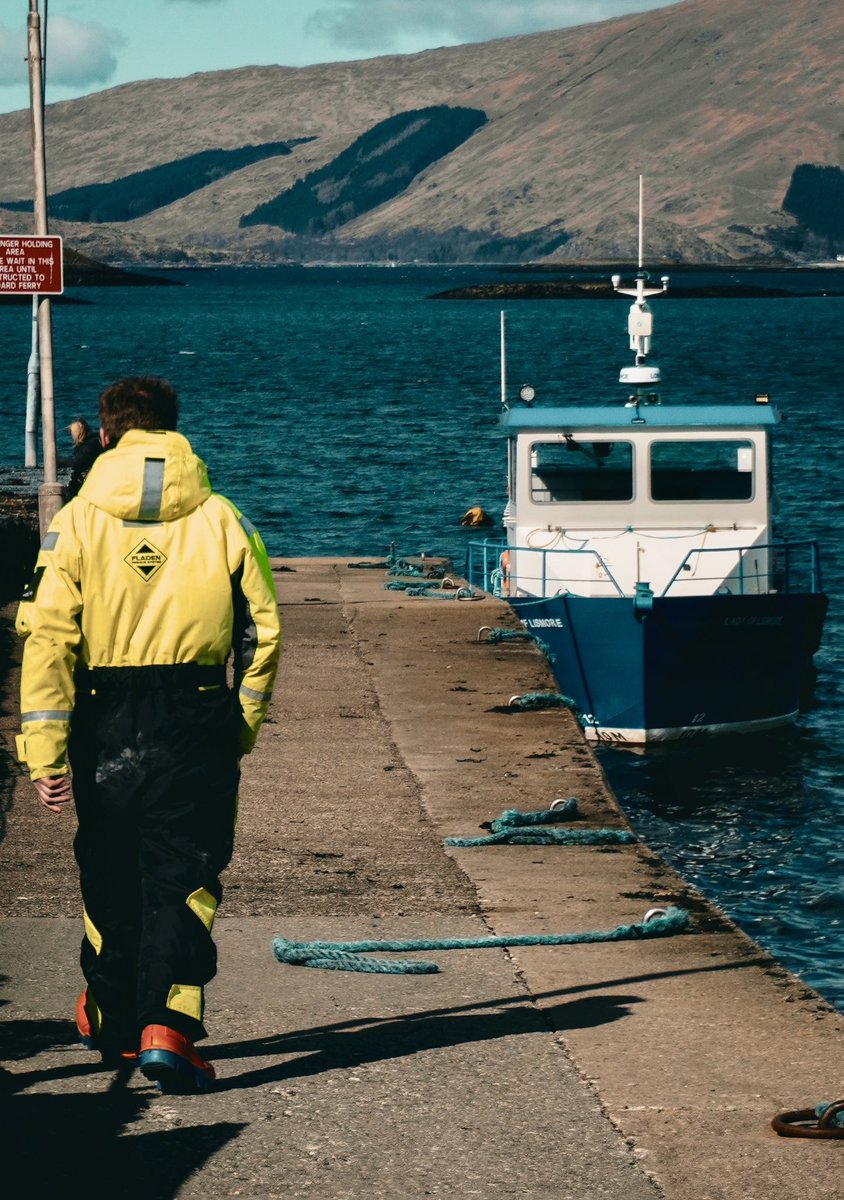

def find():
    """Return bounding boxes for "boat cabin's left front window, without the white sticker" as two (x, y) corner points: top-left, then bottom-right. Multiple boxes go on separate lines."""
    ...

(531, 433), (633, 504)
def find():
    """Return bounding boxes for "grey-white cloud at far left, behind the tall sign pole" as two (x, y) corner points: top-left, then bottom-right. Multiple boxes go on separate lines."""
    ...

(0, 17), (124, 88)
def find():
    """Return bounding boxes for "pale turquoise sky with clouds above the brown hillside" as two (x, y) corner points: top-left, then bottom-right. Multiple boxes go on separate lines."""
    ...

(0, 0), (677, 113)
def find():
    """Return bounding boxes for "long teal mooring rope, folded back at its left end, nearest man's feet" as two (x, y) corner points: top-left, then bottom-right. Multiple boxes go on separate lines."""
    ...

(273, 908), (689, 974)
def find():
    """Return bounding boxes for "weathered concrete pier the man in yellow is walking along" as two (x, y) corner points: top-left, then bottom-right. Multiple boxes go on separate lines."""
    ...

(0, 559), (844, 1200)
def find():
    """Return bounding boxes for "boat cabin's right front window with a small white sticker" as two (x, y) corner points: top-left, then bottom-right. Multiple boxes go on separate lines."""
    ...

(651, 439), (753, 502)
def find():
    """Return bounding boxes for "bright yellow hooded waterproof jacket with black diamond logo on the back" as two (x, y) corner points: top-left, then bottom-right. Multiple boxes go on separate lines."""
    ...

(17, 430), (281, 780)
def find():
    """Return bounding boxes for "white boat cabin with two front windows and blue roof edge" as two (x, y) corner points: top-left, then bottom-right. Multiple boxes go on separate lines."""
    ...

(502, 397), (779, 598)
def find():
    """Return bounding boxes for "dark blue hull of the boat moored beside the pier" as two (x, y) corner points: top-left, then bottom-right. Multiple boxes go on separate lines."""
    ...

(509, 593), (827, 744)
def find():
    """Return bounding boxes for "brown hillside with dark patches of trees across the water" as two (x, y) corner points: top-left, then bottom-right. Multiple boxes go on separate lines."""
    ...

(0, 0), (844, 263)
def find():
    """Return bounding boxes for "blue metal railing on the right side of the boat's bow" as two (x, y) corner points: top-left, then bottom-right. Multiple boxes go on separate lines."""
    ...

(662, 541), (821, 596)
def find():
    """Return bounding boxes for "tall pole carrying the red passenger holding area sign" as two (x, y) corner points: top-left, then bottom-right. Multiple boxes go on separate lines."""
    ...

(28, 0), (61, 535)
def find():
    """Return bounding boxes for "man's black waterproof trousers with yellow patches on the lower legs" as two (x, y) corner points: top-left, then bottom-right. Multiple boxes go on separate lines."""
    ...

(68, 664), (240, 1049)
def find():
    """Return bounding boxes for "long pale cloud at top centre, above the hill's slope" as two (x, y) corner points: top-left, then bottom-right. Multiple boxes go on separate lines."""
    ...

(306, 0), (677, 50)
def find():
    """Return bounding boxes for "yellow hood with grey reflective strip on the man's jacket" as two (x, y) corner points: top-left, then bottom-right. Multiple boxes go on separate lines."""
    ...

(79, 430), (211, 521)
